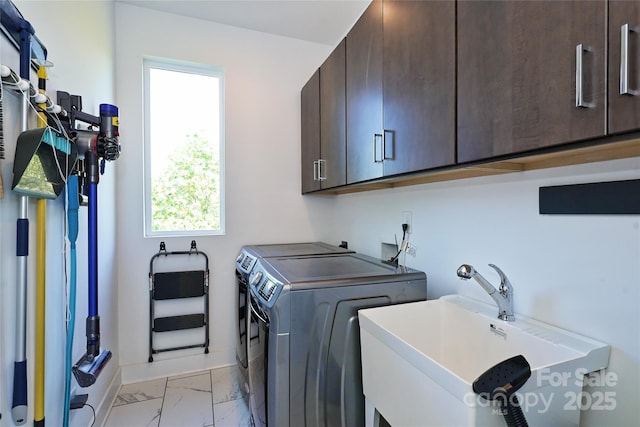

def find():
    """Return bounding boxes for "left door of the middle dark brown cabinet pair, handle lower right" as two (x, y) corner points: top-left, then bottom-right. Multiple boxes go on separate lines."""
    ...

(347, 0), (382, 184)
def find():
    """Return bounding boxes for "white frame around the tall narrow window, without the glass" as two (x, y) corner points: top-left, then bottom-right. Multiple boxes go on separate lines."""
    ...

(142, 56), (226, 238)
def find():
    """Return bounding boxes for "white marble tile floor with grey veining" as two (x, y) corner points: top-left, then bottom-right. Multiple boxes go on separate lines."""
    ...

(104, 366), (251, 427)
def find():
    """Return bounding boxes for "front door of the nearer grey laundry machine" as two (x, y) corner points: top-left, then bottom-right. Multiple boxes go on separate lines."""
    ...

(248, 293), (269, 427)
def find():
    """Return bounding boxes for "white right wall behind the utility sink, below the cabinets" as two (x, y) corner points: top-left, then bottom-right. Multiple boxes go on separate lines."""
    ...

(316, 158), (640, 427)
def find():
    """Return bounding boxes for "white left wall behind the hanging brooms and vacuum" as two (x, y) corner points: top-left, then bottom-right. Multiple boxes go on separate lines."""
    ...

(0, 1), (119, 426)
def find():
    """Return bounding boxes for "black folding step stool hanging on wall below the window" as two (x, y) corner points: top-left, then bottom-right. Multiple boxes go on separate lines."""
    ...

(149, 240), (209, 362)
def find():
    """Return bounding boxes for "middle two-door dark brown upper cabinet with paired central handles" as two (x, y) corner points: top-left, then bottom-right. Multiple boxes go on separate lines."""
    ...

(347, 0), (455, 183)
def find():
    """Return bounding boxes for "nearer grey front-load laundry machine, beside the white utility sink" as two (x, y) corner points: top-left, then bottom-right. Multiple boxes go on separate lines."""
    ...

(248, 253), (427, 427)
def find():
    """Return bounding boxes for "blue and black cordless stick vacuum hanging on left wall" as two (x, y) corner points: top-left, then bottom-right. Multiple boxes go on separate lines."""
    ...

(58, 92), (120, 387)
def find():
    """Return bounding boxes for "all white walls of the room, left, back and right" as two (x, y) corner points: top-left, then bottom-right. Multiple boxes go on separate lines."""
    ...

(0, 1), (640, 426)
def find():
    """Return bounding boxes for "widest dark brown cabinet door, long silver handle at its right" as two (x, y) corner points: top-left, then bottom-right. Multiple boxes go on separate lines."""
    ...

(457, 0), (607, 162)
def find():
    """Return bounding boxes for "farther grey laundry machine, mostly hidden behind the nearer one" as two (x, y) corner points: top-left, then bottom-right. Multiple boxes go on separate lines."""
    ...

(235, 242), (353, 405)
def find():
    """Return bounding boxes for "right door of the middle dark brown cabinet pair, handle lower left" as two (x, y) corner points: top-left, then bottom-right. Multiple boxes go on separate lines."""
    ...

(383, 0), (455, 176)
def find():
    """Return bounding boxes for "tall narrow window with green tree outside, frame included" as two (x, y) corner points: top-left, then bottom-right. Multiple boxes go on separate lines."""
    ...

(144, 58), (224, 237)
